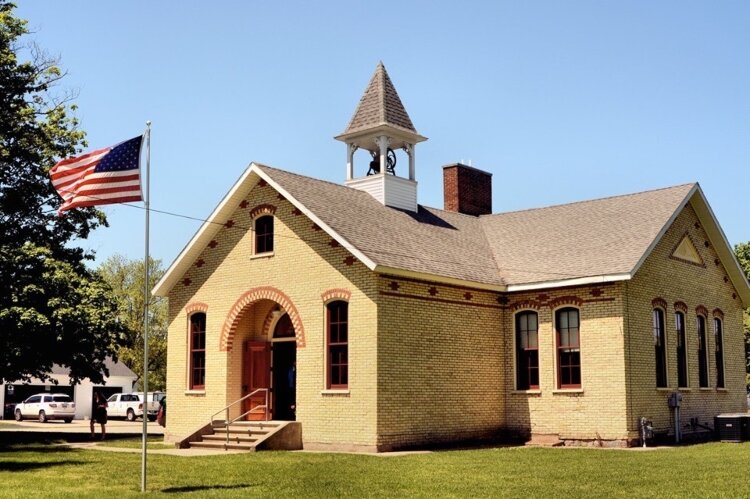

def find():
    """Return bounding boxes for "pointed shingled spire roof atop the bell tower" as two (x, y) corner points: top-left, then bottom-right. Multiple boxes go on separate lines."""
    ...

(342, 61), (417, 135)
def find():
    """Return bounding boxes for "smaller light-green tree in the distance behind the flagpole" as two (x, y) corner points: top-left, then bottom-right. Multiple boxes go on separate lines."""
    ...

(97, 255), (167, 390)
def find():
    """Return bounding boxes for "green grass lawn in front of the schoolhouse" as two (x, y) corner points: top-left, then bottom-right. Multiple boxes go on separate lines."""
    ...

(0, 433), (750, 499)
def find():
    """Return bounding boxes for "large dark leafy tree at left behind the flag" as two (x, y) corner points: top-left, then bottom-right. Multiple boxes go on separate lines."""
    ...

(0, 0), (123, 383)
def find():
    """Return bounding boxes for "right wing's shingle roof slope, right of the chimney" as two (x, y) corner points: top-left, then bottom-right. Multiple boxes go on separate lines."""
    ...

(482, 184), (695, 288)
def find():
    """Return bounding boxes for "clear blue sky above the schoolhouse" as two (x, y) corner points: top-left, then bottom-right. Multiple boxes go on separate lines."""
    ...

(17, 0), (750, 265)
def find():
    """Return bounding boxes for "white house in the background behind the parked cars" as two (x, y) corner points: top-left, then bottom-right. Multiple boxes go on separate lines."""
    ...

(0, 359), (138, 419)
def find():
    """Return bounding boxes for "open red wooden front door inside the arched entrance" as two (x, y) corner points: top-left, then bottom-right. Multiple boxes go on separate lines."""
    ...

(242, 341), (271, 421)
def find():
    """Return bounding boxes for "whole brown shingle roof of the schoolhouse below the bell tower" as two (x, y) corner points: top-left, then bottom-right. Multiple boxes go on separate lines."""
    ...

(258, 165), (694, 285)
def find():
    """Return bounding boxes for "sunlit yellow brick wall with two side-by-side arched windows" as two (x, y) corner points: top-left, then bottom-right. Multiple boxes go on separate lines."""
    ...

(503, 284), (626, 442)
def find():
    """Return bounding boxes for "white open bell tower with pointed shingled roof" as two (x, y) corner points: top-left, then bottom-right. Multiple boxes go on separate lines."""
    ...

(335, 62), (427, 211)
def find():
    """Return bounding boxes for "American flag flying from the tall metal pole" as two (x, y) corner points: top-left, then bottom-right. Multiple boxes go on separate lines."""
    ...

(49, 136), (143, 214)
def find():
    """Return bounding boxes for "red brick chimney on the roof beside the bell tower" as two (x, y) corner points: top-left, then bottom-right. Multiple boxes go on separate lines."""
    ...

(443, 163), (492, 216)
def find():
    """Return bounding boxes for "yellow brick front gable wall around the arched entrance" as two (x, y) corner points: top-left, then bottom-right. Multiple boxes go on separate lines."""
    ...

(166, 183), (377, 448)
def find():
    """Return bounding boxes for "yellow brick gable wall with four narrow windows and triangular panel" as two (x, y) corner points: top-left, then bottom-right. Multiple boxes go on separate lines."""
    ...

(624, 205), (746, 438)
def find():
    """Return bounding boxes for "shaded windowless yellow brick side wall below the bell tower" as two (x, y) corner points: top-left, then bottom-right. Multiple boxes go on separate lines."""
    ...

(377, 276), (504, 450)
